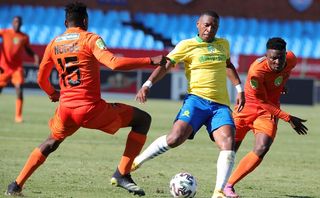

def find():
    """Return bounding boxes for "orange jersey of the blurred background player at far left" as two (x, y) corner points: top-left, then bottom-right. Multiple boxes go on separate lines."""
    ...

(0, 29), (30, 70)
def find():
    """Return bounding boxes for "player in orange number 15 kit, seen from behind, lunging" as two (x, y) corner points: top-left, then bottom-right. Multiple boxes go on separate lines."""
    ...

(6, 3), (166, 195)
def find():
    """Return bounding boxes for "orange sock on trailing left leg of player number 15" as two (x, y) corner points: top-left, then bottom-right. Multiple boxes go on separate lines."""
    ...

(16, 148), (46, 187)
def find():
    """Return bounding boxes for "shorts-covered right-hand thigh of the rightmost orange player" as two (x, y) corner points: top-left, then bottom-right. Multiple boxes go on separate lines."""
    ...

(253, 114), (278, 139)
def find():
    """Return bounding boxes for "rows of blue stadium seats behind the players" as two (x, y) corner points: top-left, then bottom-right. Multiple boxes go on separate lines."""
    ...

(0, 5), (320, 59)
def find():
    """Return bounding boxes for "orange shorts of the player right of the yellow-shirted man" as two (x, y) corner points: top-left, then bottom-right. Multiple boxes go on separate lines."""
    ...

(233, 104), (278, 142)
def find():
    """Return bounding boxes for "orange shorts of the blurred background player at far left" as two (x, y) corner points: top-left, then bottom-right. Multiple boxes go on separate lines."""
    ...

(0, 67), (24, 87)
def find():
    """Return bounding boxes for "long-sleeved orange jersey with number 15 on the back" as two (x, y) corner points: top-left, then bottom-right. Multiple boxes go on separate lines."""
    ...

(38, 27), (151, 107)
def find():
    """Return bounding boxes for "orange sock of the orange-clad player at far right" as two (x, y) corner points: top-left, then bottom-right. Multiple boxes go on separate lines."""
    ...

(228, 151), (262, 186)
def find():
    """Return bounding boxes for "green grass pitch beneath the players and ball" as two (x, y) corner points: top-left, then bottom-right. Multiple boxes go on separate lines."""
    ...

(0, 94), (320, 198)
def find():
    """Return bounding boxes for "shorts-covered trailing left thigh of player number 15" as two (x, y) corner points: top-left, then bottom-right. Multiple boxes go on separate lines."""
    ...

(48, 106), (80, 141)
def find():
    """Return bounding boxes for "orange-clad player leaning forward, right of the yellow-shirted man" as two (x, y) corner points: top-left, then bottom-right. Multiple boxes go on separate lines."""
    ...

(224, 38), (308, 198)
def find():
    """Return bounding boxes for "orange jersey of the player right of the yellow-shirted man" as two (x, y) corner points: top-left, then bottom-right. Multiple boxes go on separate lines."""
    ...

(245, 51), (297, 121)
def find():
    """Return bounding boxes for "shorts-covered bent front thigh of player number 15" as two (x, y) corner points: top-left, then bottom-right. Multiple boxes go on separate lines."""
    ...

(83, 100), (133, 134)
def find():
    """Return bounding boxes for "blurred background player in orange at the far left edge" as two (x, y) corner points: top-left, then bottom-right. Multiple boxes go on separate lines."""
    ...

(0, 16), (39, 123)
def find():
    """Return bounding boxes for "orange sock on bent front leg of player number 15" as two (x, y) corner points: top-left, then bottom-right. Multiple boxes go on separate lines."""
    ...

(118, 131), (147, 175)
